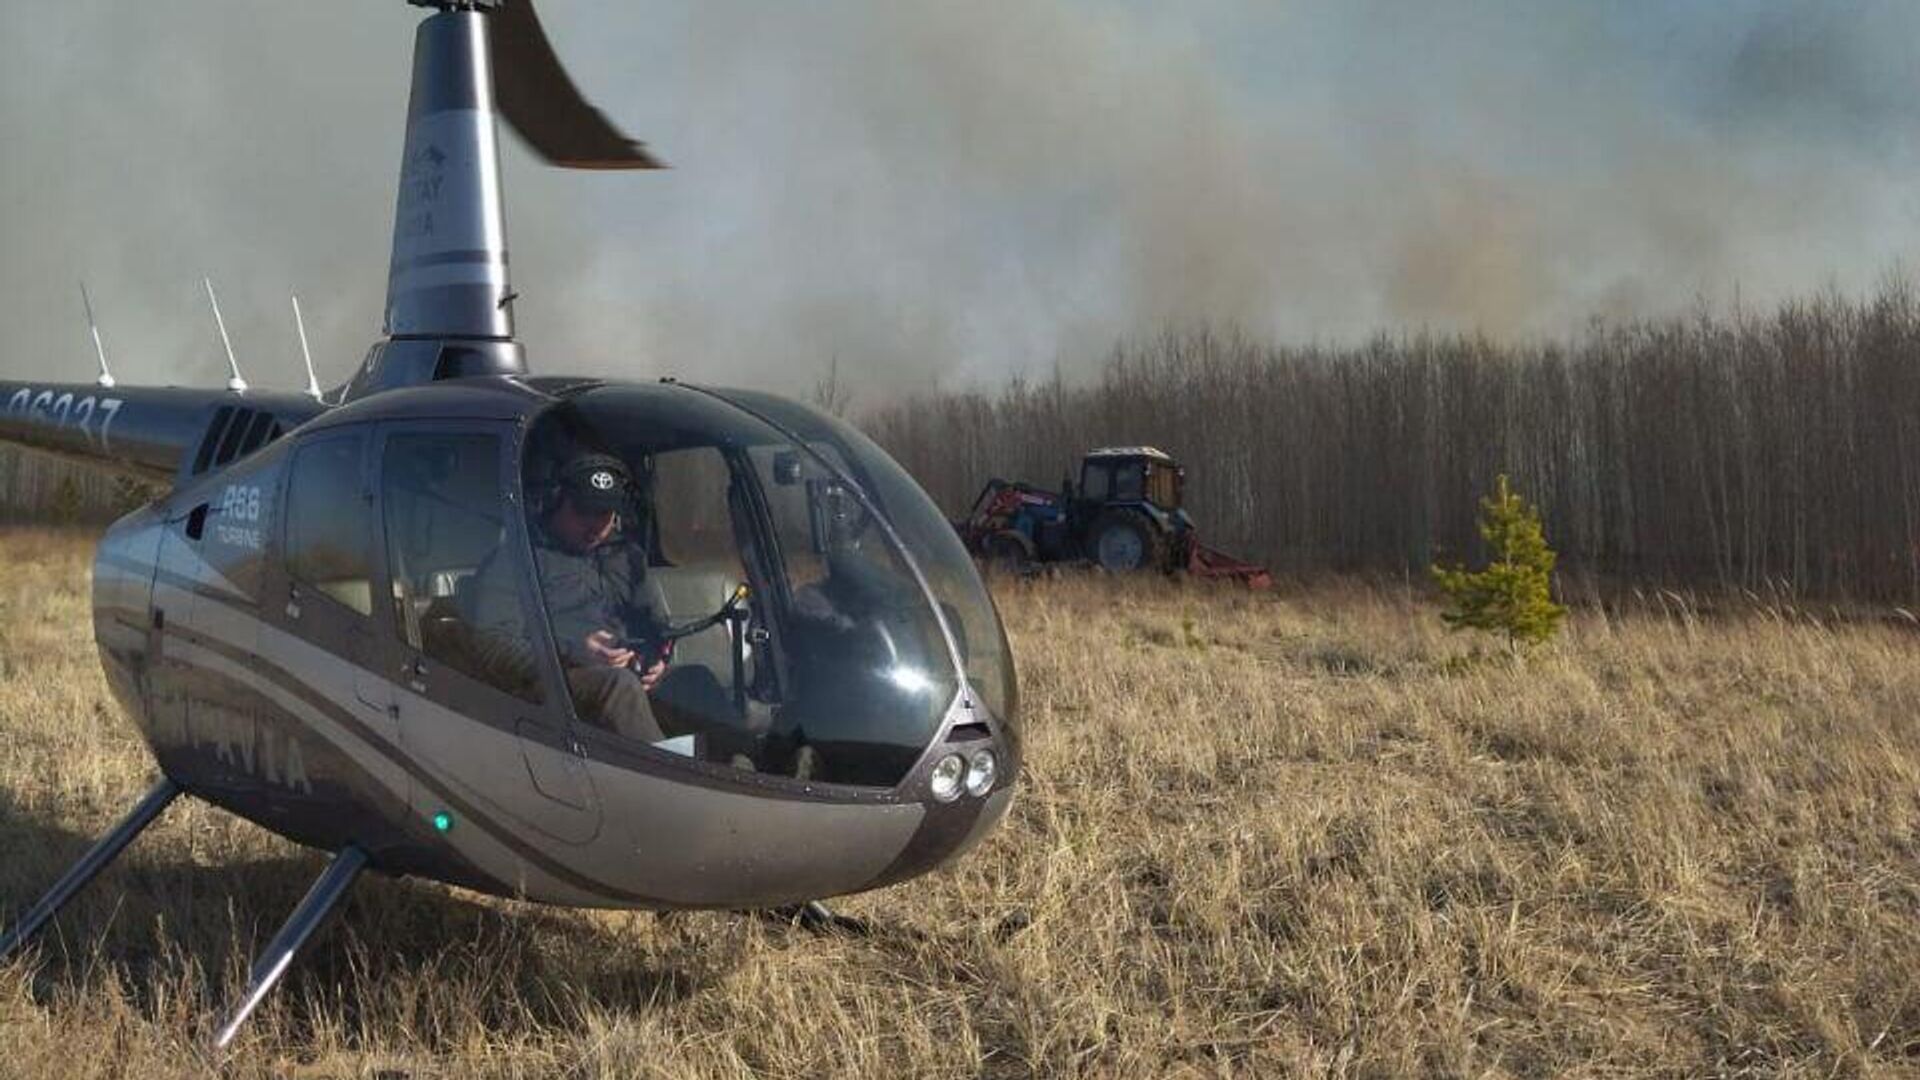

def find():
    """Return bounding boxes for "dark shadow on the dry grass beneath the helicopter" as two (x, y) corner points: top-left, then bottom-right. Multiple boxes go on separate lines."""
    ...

(0, 790), (721, 1042)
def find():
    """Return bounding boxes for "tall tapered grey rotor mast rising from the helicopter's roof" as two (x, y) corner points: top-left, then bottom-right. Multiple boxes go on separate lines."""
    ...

(386, 6), (513, 340)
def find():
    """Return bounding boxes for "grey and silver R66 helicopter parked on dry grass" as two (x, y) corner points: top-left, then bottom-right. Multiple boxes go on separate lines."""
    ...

(0, 0), (1021, 1047)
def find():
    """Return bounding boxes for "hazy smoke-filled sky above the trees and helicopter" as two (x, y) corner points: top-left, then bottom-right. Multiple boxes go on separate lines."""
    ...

(0, 0), (1920, 400)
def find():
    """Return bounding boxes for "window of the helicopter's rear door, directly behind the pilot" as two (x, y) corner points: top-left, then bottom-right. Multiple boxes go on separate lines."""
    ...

(380, 432), (541, 705)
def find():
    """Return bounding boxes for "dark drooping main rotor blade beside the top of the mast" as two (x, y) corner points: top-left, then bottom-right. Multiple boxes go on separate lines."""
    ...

(488, 0), (666, 169)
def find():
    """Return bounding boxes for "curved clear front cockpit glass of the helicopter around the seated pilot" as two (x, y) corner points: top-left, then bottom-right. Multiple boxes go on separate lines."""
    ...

(522, 386), (1012, 788)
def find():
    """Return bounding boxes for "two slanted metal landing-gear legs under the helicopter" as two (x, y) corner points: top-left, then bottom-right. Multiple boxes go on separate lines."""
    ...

(0, 778), (367, 1049)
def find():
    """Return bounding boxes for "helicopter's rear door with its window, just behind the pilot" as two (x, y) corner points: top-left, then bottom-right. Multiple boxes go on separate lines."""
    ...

(362, 423), (601, 844)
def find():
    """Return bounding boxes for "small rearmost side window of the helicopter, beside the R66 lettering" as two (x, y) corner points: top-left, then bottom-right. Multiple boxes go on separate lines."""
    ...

(286, 432), (372, 615)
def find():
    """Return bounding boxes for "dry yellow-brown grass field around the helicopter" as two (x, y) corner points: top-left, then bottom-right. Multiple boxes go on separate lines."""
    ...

(0, 532), (1920, 1078)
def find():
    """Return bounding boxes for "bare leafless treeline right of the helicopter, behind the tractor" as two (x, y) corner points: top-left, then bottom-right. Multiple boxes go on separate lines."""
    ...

(860, 282), (1920, 603)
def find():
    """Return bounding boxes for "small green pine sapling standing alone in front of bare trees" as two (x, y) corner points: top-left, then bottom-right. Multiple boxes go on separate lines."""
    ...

(1432, 475), (1567, 651)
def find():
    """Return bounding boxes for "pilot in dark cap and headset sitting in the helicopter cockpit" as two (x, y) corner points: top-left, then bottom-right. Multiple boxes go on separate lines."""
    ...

(474, 452), (666, 744)
